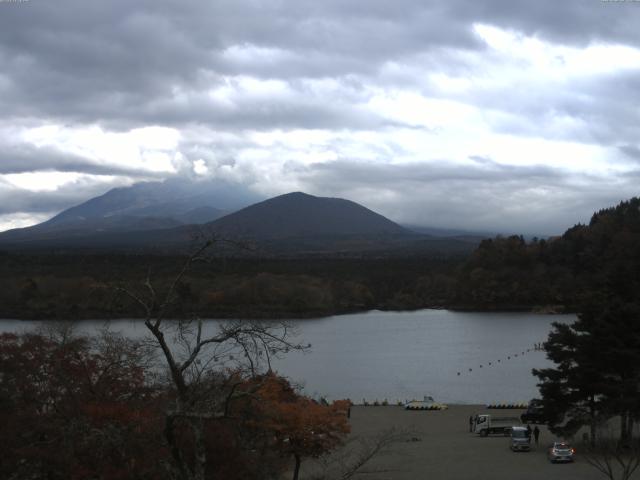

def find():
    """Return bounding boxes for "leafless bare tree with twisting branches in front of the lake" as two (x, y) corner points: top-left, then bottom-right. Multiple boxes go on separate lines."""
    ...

(118, 239), (306, 480)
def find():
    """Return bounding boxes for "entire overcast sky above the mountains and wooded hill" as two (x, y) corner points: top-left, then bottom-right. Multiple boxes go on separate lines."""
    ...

(0, 0), (640, 234)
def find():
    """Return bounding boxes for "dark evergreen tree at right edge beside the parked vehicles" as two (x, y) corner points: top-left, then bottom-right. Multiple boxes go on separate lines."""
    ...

(533, 299), (640, 443)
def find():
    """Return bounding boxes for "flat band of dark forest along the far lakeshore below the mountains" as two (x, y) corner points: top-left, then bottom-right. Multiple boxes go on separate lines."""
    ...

(0, 254), (459, 319)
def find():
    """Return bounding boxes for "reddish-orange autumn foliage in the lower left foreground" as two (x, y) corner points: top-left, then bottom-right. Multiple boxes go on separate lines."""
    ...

(0, 334), (349, 480)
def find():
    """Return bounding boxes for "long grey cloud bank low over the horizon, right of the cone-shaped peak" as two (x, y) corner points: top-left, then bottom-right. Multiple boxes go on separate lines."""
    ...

(298, 157), (636, 235)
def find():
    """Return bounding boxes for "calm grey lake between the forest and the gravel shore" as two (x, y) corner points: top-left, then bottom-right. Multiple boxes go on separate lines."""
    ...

(0, 310), (575, 404)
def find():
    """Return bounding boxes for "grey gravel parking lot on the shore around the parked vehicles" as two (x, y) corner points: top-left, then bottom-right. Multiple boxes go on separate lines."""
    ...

(301, 405), (604, 480)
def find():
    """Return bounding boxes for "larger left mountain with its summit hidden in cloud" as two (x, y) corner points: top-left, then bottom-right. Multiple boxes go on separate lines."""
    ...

(0, 179), (261, 243)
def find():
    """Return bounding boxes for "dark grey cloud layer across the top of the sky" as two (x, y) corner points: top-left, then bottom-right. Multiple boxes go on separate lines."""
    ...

(0, 0), (640, 128)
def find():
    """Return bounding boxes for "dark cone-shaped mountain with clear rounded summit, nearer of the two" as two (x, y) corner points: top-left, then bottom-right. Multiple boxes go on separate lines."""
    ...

(208, 192), (411, 239)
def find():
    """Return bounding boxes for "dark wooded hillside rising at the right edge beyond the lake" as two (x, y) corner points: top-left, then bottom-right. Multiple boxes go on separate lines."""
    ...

(451, 198), (640, 311)
